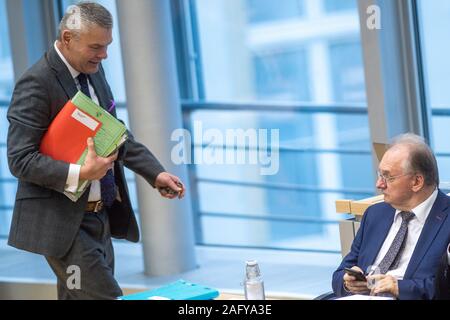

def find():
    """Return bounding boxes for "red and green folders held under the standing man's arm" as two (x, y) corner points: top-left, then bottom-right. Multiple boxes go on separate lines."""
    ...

(40, 91), (128, 201)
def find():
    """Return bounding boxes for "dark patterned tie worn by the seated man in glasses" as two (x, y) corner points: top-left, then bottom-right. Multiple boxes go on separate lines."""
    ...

(378, 211), (414, 274)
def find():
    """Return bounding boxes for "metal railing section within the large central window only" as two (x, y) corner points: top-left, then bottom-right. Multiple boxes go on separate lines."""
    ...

(182, 101), (374, 253)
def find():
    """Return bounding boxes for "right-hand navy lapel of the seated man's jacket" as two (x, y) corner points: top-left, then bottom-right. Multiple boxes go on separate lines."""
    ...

(405, 191), (448, 278)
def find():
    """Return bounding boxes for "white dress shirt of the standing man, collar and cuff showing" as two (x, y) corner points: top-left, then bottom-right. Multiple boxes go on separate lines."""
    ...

(53, 41), (101, 201)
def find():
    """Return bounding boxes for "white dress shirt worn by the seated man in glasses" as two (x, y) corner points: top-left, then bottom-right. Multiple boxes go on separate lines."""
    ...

(370, 189), (438, 280)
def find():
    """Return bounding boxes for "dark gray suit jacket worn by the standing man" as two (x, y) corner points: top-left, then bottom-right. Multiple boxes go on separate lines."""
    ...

(7, 48), (164, 257)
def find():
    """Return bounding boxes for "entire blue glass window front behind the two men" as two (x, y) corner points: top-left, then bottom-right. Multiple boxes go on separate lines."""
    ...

(0, 0), (442, 252)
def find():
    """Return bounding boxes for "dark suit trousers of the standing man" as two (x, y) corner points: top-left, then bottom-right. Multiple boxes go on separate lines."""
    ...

(45, 210), (122, 300)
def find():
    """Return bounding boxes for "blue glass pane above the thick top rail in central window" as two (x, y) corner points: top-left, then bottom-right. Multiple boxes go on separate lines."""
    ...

(193, 0), (366, 103)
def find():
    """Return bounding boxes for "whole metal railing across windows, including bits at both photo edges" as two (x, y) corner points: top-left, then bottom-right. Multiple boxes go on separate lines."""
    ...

(0, 100), (450, 249)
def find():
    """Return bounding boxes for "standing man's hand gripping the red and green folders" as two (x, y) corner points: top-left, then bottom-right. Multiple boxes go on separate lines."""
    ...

(80, 138), (118, 180)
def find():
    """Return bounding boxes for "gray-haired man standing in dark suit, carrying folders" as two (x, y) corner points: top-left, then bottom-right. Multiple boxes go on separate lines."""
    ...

(8, 3), (185, 299)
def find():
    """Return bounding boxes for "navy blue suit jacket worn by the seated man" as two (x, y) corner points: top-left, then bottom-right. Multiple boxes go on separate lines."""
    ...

(332, 191), (450, 300)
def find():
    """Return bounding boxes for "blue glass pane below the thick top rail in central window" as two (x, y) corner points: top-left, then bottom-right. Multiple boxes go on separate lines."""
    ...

(185, 111), (375, 249)
